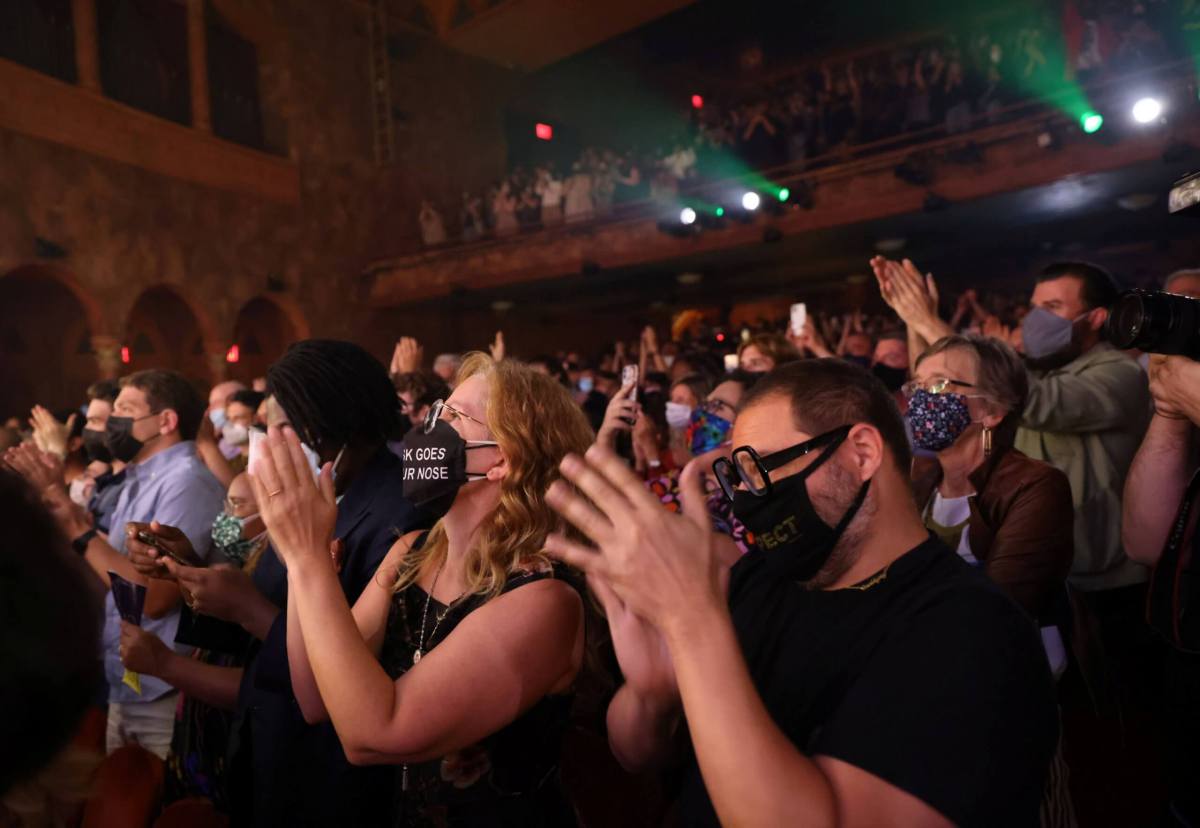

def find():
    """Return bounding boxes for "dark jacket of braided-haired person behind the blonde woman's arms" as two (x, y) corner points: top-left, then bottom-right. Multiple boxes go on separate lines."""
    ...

(228, 448), (430, 826)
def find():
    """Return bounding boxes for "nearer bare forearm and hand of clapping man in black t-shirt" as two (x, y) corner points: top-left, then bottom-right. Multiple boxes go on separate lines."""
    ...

(547, 448), (949, 827)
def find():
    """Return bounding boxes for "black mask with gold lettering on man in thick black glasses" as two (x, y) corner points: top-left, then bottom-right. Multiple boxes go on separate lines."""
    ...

(733, 434), (871, 581)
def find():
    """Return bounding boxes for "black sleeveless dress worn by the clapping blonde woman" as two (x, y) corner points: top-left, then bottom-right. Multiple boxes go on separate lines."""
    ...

(379, 552), (576, 828)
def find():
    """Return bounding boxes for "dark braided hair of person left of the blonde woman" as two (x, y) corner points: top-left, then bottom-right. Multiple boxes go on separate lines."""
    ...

(266, 340), (400, 450)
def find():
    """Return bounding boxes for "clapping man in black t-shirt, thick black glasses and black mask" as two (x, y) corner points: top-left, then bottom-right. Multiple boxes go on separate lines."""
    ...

(547, 360), (1057, 828)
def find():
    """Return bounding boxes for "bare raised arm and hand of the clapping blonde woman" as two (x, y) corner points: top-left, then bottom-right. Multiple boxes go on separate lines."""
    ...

(251, 428), (583, 763)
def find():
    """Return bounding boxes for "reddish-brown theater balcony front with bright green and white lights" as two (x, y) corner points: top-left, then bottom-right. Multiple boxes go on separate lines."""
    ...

(361, 53), (1200, 326)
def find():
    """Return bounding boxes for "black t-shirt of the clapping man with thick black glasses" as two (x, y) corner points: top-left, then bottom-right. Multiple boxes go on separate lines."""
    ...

(680, 539), (1057, 828)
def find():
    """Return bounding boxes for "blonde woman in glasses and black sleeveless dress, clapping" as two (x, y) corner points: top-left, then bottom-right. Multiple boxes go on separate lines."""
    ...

(252, 354), (593, 826)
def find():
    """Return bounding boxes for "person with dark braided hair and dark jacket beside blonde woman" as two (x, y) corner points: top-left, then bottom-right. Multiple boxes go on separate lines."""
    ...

(229, 340), (431, 826)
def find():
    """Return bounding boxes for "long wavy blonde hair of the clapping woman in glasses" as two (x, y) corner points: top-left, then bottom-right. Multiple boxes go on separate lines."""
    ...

(394, 352), (595, 599)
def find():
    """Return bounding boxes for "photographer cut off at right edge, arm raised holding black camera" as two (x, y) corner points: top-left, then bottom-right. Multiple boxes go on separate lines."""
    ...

(1122, 312), (1200, 824)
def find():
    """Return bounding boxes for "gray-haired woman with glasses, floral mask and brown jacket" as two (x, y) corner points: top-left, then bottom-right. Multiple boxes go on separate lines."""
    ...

(904, 335), (1074, 677)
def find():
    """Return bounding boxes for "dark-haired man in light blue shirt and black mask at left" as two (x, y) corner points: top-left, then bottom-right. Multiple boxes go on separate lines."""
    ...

(62, 371), (224, 758)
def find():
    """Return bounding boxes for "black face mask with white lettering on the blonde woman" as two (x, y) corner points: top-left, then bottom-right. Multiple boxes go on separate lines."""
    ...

(401, 420), (496, 520)
